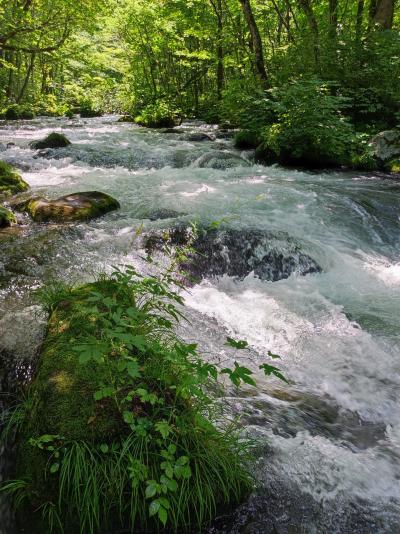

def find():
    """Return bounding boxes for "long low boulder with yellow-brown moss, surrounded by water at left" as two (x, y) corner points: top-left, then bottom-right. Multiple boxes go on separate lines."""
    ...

(25, 191), (120, 223)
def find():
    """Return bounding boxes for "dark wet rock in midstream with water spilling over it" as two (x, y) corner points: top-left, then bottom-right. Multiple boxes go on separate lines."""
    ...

(145, 226), (322, 282)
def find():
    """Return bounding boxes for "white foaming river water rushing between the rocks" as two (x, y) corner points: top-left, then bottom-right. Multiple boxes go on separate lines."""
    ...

(0, 117), (400, 534)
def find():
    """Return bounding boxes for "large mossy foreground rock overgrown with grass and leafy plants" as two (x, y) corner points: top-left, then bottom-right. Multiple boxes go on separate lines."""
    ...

(2, 267), (283, 534)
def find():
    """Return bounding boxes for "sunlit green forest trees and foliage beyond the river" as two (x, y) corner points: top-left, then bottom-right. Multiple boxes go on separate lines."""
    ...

(0, 0), (400, 166)
